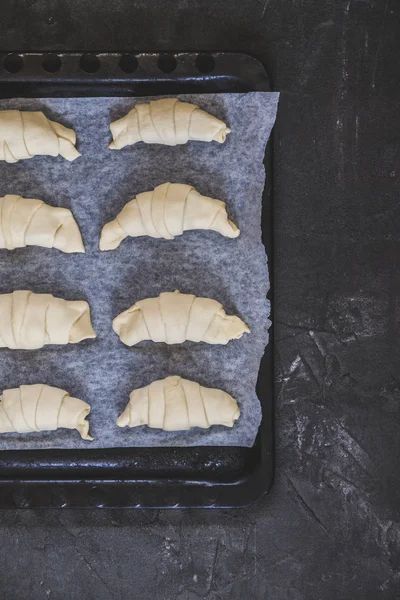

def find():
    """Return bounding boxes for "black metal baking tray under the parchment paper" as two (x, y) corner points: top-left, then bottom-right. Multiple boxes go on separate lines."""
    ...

(0, 53), (274, 508)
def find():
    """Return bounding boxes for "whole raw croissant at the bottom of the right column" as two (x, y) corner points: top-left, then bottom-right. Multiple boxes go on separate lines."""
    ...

(117, 375), (240, 431)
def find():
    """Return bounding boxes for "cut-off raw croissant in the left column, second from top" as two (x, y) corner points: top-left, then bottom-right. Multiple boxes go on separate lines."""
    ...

(0, 194), (85, 252)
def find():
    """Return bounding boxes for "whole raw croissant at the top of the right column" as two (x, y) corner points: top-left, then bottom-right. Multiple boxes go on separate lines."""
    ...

(109, 98), (231, 150)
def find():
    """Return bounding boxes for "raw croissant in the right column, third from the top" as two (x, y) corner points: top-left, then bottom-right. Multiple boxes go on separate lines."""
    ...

(113, 290), (250, 346)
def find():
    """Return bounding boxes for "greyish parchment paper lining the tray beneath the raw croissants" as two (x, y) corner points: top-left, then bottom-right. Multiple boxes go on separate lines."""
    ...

(0, 92), (279, 449)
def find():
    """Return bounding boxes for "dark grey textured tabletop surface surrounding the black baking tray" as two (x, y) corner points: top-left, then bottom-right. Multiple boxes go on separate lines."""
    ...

(0, 0), (400, 600)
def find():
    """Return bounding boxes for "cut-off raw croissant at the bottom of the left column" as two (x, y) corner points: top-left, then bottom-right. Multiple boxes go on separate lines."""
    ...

(0, 383), (93, 440)
